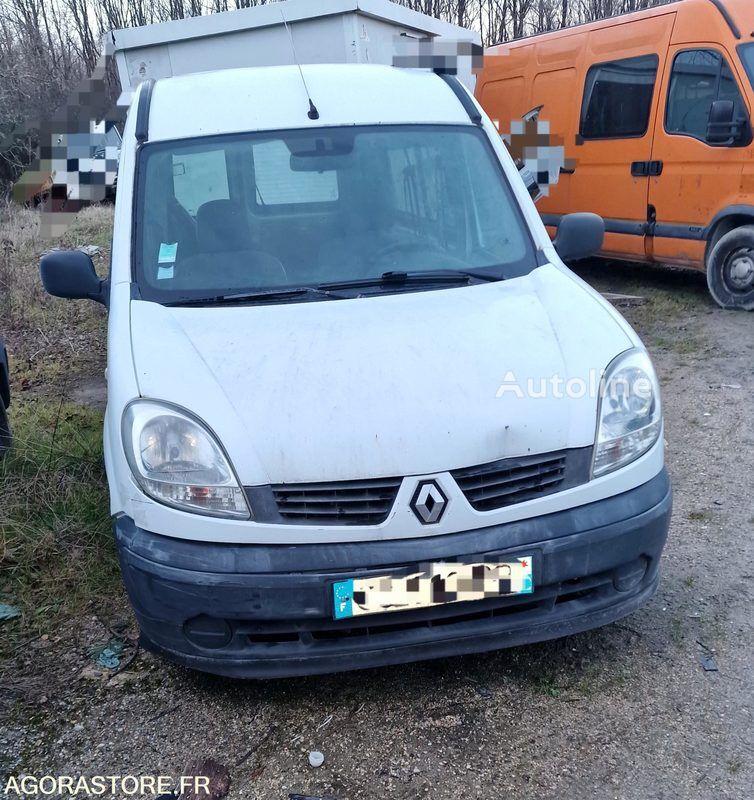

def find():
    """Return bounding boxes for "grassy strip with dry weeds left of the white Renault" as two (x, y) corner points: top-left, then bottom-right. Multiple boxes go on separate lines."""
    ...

(0, 206), (121, 650)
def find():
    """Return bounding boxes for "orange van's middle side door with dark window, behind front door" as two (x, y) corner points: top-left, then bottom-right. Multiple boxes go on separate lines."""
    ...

(564, 12), (675, 259)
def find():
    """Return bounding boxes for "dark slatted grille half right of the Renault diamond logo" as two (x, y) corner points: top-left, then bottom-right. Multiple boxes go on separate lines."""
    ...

(451, 448), (591, 511)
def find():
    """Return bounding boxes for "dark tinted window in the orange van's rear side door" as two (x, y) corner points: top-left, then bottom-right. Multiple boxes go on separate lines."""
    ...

(580, 55), (660, 139)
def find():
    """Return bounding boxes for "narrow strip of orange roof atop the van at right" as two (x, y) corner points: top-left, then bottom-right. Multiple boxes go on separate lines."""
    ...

(488, 0), (754, 54)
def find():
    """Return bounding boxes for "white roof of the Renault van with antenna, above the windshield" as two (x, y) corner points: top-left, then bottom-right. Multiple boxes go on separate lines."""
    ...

(142, 64), (471, 141)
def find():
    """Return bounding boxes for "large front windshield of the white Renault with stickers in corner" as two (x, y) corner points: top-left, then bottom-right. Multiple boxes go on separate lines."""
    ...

(135, 126), (535, 302)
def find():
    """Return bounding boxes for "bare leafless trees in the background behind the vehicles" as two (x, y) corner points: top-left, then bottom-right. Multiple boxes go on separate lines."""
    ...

(0, 0), (667, 196)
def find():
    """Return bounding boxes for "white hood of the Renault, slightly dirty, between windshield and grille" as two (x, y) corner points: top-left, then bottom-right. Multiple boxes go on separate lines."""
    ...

(131, 266), (633, 485)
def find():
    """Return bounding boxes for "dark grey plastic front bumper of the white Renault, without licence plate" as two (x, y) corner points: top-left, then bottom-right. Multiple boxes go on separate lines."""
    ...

(115, 470), (672, 678)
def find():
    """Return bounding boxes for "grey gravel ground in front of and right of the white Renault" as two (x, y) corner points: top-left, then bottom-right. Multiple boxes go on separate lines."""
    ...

(0, 262), (754, 800)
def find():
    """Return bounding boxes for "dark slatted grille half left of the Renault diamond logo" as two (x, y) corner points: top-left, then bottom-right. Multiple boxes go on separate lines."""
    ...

(272, 478), (401, 525)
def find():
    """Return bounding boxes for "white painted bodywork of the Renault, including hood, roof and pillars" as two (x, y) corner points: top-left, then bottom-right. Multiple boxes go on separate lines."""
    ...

(105, 66), (663, 543)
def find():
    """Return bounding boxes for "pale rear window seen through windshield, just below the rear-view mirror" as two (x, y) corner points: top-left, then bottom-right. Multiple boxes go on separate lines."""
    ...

(252, 139), (338, 207)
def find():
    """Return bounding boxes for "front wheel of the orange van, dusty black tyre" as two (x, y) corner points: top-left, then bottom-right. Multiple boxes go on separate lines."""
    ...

(707, 225), (754, 311)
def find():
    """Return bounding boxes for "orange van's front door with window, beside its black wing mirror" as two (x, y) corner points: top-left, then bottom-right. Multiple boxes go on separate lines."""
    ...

(649, 44), (751, 266)
